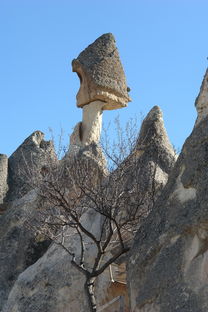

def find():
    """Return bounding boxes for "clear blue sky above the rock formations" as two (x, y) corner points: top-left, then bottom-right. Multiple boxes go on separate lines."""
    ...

(0, 0), (208, 155)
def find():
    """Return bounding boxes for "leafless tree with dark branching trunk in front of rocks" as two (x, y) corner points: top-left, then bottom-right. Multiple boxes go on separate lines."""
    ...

(21, 120), (158, 312)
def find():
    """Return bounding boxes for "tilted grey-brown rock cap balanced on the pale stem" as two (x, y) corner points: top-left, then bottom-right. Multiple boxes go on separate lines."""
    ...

(72, 33), (130, 110)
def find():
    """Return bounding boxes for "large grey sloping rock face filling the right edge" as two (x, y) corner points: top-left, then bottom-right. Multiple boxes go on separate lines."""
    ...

(128, 69), (208, 312)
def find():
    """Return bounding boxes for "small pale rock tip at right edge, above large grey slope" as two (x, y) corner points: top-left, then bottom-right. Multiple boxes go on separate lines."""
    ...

(195, 68), (208, 126)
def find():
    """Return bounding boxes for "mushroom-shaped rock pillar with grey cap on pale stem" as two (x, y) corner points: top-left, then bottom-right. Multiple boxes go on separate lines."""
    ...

(71, 33), (130, 146)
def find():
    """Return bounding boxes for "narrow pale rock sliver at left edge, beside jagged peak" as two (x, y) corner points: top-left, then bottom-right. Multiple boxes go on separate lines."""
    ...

(0, 154), (8, 204)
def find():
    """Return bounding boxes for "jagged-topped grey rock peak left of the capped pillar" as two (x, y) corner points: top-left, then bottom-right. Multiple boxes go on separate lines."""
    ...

(6, 131), (56, 201)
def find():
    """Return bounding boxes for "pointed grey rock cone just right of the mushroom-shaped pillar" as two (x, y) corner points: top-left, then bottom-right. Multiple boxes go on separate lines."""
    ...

(111, 106), (176, 229)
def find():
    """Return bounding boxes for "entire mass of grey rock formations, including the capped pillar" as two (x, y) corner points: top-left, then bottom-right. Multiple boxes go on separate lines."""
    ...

(0, 34), (208, 312)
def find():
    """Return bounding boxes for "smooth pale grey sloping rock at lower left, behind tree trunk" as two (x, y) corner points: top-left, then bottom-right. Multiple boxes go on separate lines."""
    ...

(2, 207), (100, 312)
